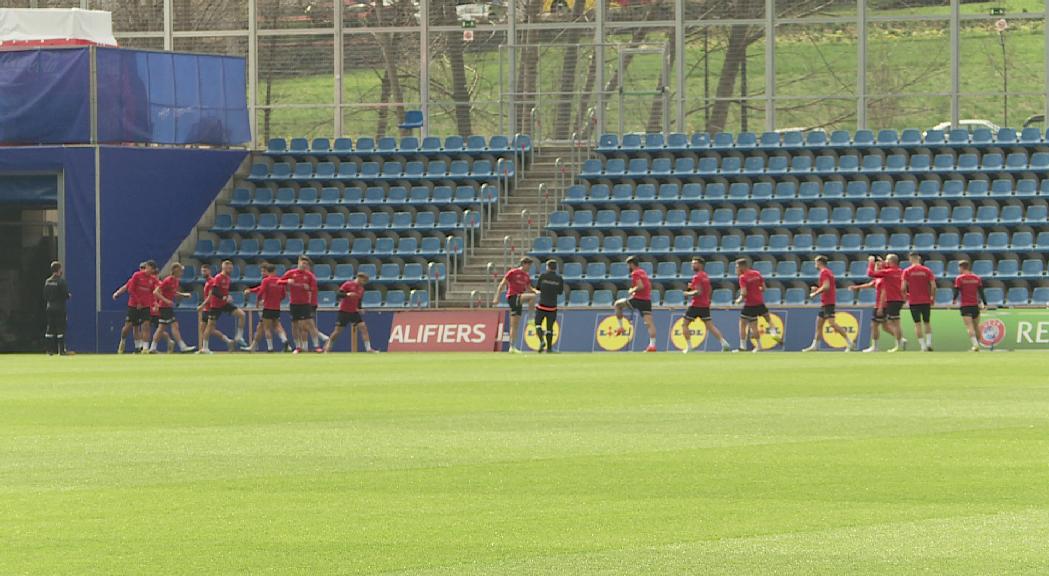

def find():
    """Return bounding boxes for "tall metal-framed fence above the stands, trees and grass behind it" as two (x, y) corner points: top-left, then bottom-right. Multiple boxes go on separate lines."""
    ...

(77, 0), (1049, 143)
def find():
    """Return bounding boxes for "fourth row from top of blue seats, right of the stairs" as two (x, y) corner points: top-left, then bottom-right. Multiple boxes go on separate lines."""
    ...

(548, 204), (1049, 231)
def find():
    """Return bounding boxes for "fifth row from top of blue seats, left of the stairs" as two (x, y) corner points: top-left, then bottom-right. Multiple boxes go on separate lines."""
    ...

(193, 236), (462, 260)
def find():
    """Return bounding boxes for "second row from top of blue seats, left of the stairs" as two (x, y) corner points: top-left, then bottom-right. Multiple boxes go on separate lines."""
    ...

(248, 159), (514, 183)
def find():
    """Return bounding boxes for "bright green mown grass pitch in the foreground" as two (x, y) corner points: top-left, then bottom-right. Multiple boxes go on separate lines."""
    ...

(0, 353), (1049, 575)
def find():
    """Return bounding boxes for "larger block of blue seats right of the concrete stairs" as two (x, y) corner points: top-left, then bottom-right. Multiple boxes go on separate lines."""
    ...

(537, 128), (1049, 305)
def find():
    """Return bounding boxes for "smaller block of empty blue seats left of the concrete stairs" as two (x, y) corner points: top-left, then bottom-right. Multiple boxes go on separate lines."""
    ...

(185, 136), (524, 308)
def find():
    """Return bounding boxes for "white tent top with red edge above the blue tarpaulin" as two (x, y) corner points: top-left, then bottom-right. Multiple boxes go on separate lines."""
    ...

(0, 8), (116, 49)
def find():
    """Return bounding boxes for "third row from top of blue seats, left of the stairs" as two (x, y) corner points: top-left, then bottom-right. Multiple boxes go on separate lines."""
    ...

(230, 186), (498, 207)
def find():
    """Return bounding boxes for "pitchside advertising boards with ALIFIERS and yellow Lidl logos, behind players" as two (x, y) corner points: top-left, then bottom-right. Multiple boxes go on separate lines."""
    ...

(99, 306), (1049, 353)
